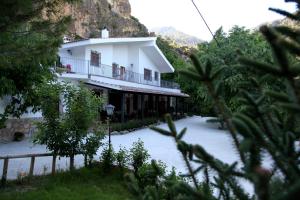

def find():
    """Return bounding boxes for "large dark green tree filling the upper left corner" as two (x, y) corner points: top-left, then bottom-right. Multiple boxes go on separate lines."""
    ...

(0, 0), (76, 128)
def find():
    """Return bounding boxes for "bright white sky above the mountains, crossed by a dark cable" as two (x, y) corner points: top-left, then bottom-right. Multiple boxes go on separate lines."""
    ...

(129, 0), (295, 41)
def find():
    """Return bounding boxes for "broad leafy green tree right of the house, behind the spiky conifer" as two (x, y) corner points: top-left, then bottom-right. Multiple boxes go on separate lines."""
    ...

(195, 26), (281, 113)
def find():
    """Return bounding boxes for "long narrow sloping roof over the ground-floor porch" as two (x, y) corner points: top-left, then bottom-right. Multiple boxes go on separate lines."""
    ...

(85, 81), (189, 97)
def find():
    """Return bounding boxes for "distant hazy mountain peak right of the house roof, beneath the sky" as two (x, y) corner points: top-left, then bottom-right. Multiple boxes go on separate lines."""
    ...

(151, 27), (204, 47)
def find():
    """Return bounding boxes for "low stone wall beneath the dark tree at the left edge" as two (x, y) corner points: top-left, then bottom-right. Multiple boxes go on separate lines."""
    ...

(0, 118), (41, 143)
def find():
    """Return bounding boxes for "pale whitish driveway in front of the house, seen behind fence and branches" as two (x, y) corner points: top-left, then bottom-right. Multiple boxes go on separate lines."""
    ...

(0, 116), (269, 192)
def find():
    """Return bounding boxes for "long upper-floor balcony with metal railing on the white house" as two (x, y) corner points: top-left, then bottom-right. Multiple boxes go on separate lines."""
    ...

(55, 57), (180, 89)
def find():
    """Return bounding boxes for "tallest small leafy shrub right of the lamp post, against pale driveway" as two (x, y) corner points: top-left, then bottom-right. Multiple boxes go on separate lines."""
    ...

(130, 139), (150, 176)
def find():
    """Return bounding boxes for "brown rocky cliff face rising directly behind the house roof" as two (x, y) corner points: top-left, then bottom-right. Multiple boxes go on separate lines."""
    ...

(61, 0), (149, 38)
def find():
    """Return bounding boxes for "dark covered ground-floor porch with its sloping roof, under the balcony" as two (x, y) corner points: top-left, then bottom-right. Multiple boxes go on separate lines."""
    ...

(87, 83), (188, 122)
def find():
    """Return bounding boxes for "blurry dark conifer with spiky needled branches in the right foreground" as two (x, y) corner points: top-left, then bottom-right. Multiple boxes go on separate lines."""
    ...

(128, 0), (300, 200)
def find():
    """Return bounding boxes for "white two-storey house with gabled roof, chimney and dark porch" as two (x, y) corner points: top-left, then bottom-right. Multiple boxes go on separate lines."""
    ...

(0, 29), (188, 142)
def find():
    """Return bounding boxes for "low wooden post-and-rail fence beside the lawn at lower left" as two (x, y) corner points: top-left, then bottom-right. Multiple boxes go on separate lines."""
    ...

(0, 153), (69, 185)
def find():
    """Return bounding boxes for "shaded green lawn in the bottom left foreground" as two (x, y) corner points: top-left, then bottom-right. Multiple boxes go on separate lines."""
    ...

(0, 168), (133, 200)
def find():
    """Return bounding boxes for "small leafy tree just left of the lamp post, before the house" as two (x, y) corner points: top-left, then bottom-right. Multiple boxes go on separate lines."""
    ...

(35, 83), (104, 169)
